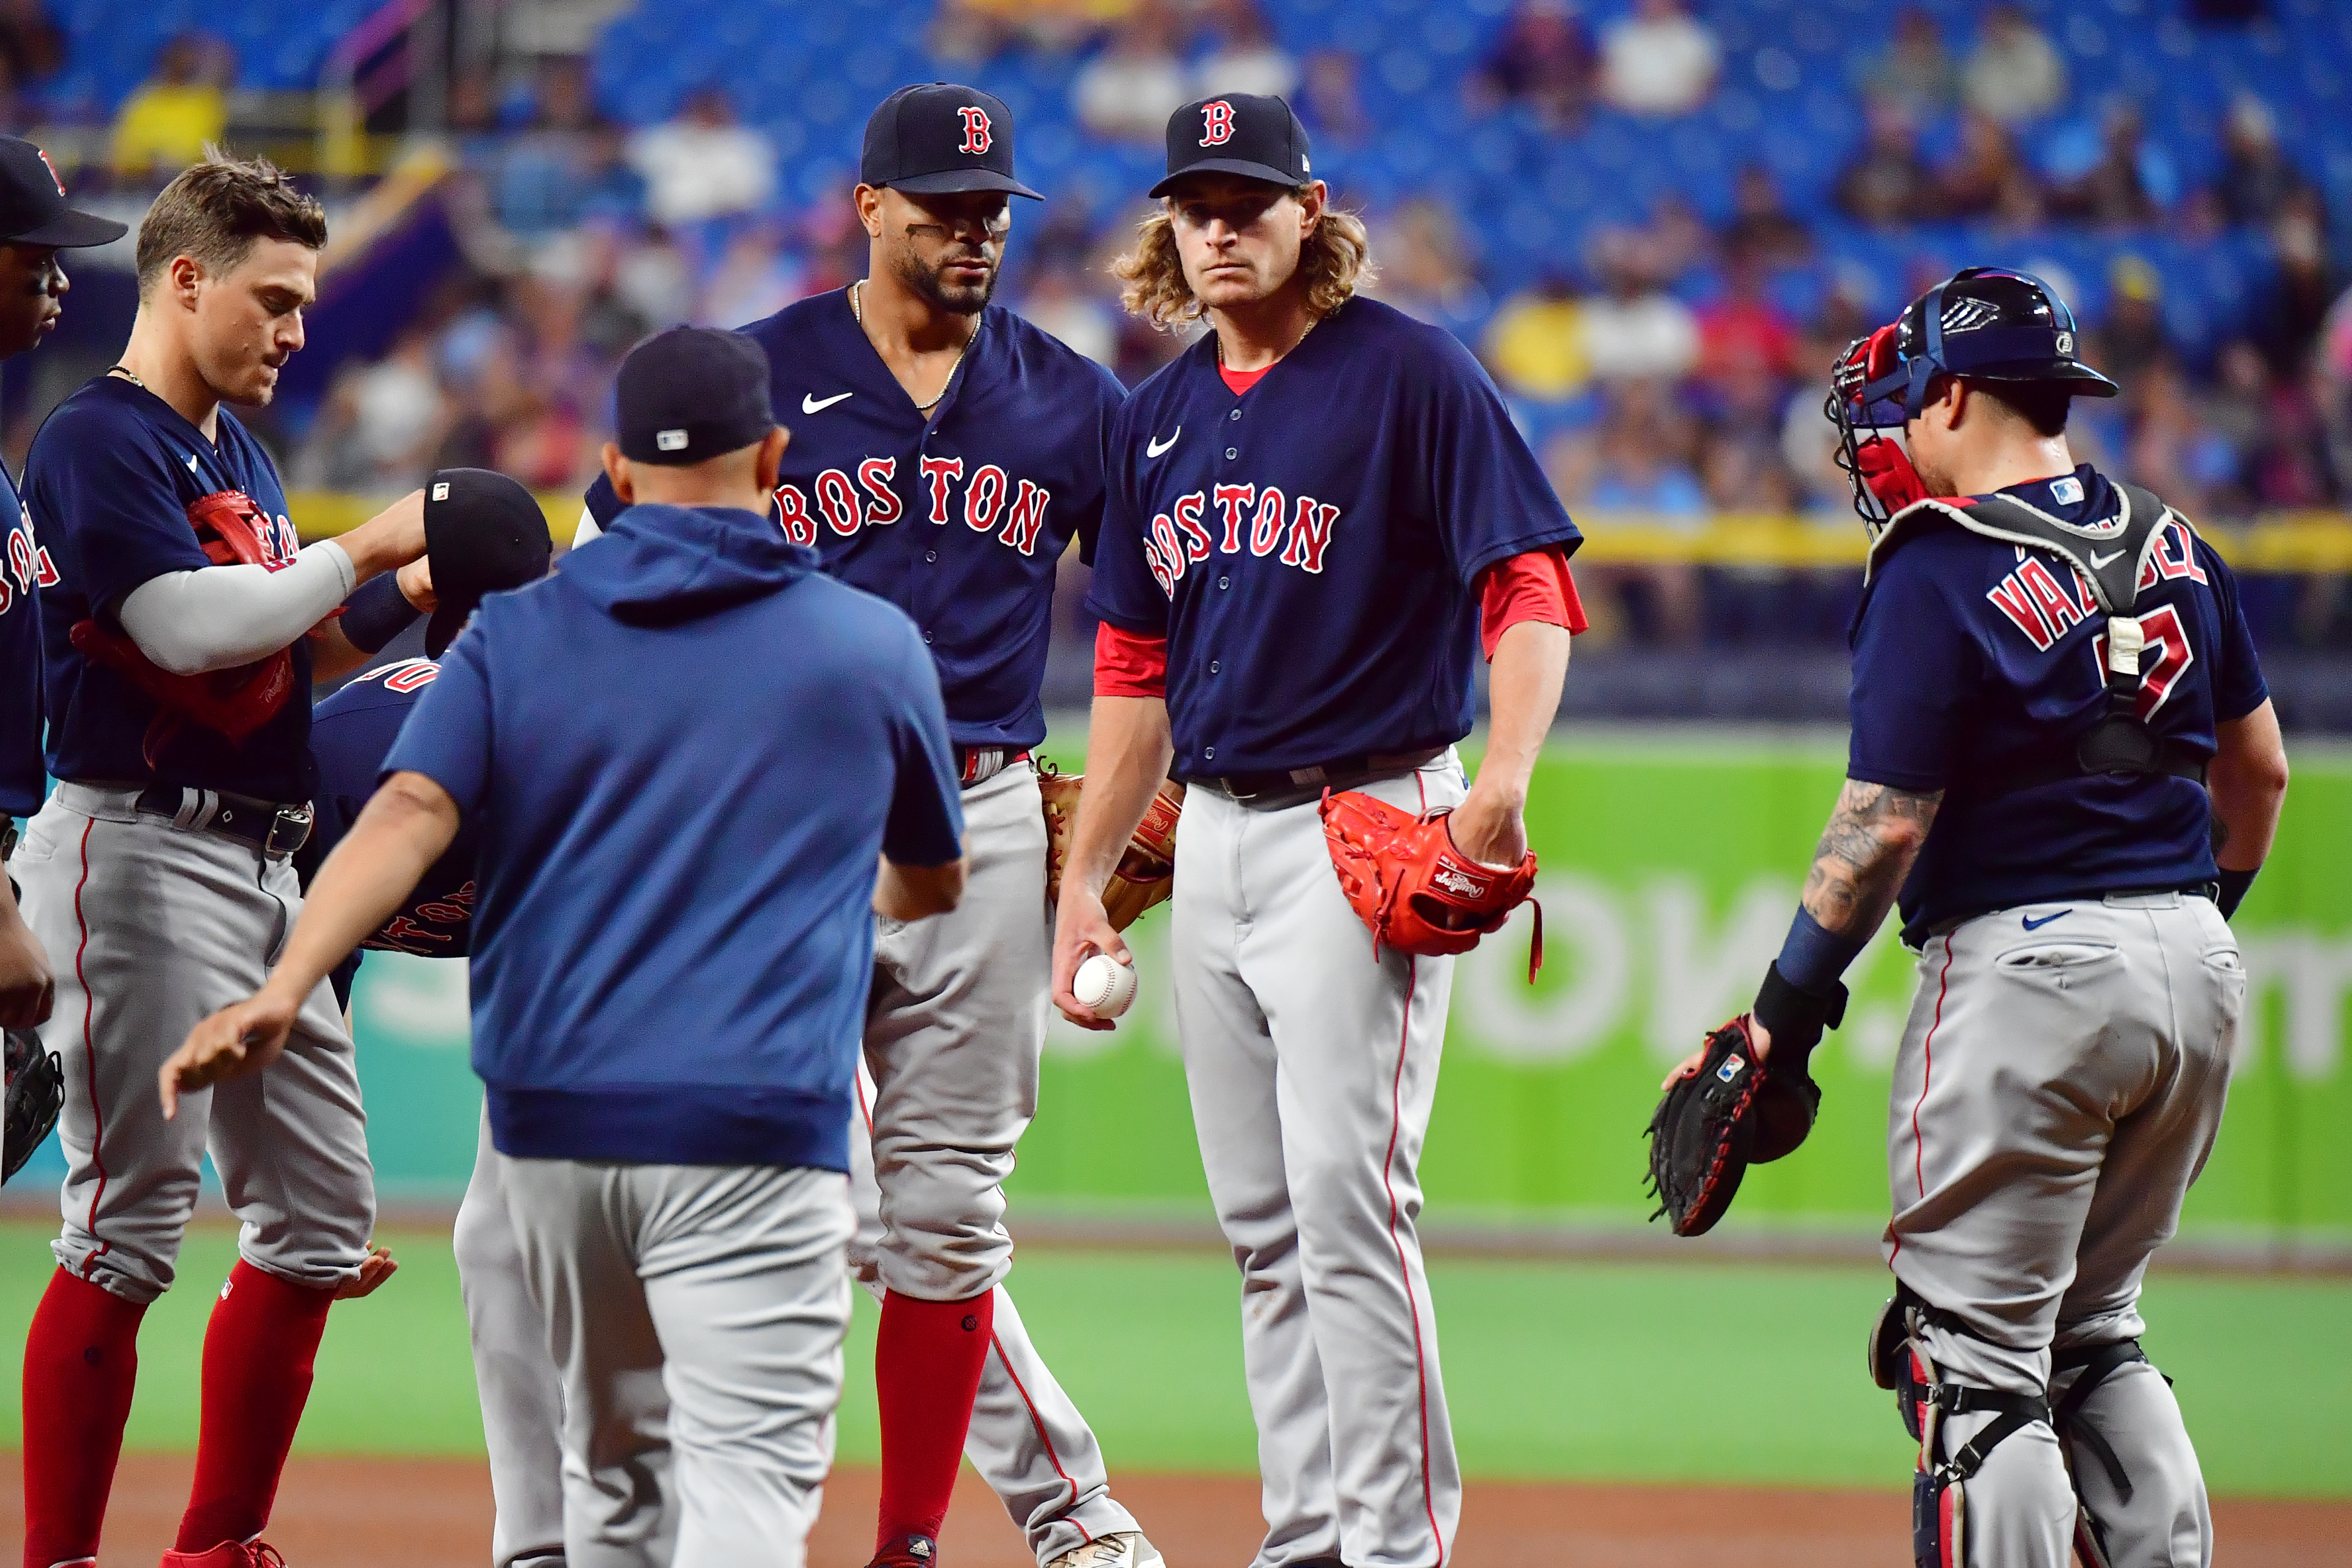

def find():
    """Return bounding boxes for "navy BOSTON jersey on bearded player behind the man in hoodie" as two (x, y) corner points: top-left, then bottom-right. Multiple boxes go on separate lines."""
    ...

(588, 289), (1124, 748)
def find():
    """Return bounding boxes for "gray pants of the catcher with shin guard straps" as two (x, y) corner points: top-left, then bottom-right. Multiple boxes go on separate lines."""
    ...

(1886, 893), (2246, 1568)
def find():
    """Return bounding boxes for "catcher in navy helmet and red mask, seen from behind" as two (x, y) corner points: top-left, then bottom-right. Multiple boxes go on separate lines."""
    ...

(1661, 268), (2286, 1568)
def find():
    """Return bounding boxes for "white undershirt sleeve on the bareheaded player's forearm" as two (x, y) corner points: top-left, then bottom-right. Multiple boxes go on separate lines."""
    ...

(115, 538), (358, 675)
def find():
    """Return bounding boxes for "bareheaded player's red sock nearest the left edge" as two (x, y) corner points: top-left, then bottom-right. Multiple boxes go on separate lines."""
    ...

(24, 1269), (146, 1568)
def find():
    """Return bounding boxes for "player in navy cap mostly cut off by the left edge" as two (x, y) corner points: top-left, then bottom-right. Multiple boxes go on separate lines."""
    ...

(0, 136), (125, 1044)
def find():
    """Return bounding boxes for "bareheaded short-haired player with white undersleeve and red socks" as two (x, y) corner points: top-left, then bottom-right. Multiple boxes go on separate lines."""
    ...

(12, 160), (426, 1568)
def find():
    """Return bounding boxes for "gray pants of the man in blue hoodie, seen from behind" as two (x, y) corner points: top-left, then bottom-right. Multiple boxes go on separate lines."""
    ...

(498, 1154), (854, 1568)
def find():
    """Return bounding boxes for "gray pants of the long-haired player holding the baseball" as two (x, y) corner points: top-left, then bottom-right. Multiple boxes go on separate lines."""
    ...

(1171, 752), (1467, 1568)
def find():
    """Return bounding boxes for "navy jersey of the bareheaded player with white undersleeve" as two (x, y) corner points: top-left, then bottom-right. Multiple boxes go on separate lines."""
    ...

(24, 376), (315, 802)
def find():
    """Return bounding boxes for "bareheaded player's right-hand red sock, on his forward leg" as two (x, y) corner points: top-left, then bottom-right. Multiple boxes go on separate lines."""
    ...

(177, 1258), (334, 1551)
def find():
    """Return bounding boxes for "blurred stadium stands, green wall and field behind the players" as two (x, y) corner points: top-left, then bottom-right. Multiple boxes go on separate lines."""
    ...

(0, 0), (2352, 1568)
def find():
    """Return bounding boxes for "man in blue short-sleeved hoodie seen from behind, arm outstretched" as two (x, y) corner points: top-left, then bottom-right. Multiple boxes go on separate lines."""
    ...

(162, 327), (965, 1568)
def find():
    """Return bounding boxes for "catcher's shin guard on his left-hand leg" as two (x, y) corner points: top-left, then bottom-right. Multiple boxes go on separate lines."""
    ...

(1870, 1288), (2051, 1568)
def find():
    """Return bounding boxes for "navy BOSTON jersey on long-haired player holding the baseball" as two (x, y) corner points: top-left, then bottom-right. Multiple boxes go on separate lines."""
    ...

(1087, 299), (1583, 778)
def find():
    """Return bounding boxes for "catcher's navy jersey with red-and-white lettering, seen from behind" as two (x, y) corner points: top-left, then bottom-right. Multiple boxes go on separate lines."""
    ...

(1846, 463), (2270, 945)
